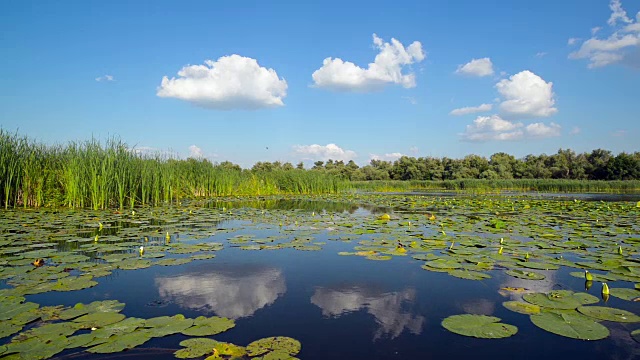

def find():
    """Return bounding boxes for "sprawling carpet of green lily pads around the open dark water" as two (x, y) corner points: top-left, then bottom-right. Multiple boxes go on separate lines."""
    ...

(0, 194), (640, 359)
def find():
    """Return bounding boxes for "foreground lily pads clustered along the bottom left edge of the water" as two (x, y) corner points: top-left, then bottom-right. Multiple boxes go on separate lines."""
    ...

(0, 297), (301, 359)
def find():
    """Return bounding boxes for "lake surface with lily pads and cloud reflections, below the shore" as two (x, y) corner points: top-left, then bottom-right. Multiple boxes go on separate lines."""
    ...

(0, 194), (640, 359)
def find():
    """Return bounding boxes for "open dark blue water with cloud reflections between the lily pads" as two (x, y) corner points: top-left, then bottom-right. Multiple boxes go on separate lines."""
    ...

(17, 222), (640, 360)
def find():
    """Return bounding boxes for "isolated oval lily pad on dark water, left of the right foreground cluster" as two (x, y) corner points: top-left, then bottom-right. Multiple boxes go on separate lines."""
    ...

(442, 314), (518, 339)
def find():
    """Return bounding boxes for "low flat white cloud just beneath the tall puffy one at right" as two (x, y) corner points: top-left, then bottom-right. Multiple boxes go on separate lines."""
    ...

(460, 115), (561, 142)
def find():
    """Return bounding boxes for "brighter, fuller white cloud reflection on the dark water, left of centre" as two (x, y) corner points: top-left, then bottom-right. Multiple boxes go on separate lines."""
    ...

(155, 265), (287, 319)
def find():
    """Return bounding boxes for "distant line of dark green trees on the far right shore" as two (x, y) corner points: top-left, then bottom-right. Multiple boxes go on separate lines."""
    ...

(252, 149), (640, 180)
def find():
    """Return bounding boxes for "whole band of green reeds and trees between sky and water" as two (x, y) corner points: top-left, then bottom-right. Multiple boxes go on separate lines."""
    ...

(0, 129), (640, 210)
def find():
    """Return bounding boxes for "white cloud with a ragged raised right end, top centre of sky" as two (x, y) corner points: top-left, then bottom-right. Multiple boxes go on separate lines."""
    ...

(311, 34), (426, 92)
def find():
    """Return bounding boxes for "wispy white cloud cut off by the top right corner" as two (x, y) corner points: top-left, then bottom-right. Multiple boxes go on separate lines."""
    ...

(569, 0), (640, 68)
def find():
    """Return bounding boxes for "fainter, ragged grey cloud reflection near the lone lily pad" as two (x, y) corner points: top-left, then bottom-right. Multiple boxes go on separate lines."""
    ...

(311, 286), (425, 340)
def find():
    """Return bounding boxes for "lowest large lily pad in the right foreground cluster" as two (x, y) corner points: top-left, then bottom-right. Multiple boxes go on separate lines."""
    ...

(529, 312), (609, 340)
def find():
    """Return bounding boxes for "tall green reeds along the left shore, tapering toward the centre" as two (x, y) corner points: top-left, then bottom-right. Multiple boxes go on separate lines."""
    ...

(0, 129), (347, 210)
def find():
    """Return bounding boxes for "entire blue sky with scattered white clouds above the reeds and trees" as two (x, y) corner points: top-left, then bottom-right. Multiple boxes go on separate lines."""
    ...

(0, 0), (640, 167)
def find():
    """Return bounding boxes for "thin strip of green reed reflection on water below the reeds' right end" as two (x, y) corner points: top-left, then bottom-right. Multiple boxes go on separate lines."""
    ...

(206, 199), (389, 214)
